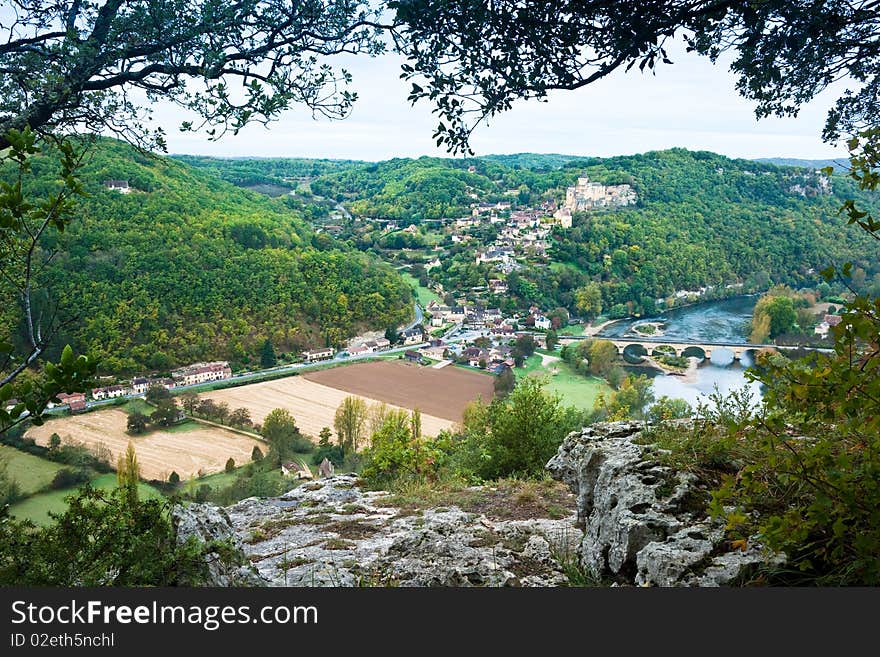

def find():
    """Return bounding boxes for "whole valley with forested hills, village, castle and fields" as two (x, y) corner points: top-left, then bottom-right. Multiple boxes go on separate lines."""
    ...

(3, 141), (880, 544)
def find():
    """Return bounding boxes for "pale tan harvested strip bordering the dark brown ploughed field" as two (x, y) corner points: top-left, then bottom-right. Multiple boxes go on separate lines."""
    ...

(200, 363), (470, 437)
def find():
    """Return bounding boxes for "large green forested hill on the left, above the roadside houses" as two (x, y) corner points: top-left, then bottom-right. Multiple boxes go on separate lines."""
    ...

(6, 140), (411, 374)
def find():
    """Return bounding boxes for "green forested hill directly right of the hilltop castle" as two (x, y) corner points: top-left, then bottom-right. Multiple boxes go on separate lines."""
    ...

(554, 149), (880, 312)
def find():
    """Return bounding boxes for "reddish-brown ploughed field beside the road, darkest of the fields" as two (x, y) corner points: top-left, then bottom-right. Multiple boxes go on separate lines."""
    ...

(303, 360), (495, 422)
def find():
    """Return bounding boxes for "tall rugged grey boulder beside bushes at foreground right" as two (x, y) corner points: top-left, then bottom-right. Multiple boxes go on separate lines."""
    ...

(547, 422), (781, 586)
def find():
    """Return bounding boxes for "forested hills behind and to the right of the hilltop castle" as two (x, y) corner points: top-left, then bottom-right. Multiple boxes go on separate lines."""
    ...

(186, 148), (880, 313)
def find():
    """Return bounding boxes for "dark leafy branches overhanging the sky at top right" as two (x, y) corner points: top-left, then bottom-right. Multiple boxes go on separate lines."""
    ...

(389, 0), (880, 151)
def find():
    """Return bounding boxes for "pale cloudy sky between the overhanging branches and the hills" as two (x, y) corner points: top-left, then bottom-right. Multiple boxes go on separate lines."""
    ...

(155, 38), (846, 160)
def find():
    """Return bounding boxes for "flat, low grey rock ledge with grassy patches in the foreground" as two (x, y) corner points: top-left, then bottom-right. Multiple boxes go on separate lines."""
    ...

(181, 475), (581, 586)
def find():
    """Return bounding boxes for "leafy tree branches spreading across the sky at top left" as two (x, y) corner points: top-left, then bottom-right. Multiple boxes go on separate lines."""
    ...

(0, 0), (392, 148)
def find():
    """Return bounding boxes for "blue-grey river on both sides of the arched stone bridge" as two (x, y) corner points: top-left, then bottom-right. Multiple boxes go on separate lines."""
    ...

(597, 296), (761, 406)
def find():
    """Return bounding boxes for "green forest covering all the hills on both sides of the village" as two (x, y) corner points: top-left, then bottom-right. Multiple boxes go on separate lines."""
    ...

(5, 145), (880, 375)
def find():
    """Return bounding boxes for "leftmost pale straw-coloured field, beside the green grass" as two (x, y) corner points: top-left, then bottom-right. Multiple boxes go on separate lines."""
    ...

(27, 409), (266, 480)
